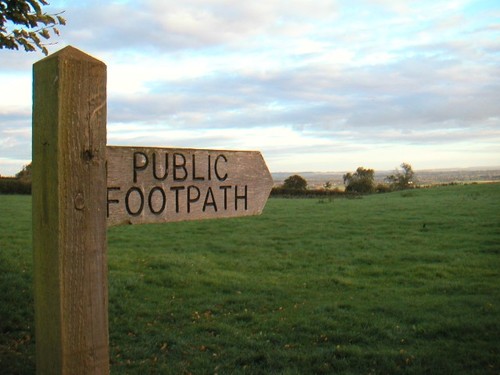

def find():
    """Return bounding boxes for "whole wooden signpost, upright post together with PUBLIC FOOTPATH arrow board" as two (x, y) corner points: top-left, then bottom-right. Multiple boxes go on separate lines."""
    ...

(32, 47), (272, 375)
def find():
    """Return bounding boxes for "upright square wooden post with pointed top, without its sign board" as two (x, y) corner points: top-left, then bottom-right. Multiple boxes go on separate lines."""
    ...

(33, 47), (109, 374)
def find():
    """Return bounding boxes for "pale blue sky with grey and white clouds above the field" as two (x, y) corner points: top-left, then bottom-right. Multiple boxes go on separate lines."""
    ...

(0, 0), (500, 176)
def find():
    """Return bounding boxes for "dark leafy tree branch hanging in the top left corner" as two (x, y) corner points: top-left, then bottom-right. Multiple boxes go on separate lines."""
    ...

(0, 0), (66, 55)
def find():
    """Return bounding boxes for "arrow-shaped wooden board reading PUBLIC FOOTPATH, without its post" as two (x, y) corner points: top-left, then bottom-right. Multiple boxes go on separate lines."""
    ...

(106, 146), (273, 226)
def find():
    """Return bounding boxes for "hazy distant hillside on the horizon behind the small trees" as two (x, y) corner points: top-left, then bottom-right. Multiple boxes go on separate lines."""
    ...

(272, 167), (500, 187)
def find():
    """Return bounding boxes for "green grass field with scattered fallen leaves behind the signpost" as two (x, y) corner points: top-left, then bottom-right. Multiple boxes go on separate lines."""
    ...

(0, 184), (500, 375)
